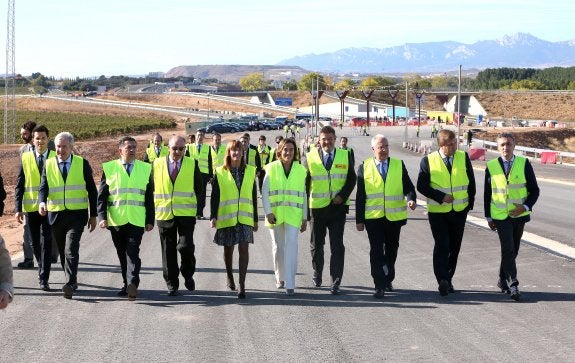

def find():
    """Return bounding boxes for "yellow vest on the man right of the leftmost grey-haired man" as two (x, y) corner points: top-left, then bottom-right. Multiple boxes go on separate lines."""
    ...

(102, 159), (152, 227)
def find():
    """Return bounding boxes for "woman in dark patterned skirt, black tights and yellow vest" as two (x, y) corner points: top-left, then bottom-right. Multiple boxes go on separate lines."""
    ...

(210, 140), (258, 299)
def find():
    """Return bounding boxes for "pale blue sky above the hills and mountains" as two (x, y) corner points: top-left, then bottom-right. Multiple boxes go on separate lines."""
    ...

(4, 0), (575, 77)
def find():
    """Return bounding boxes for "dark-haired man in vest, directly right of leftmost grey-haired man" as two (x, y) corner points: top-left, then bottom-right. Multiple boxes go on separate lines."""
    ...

(98, 136), (154, 301)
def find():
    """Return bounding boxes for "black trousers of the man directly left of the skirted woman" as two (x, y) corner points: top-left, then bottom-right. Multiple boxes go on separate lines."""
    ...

(157, 217), (196, 290)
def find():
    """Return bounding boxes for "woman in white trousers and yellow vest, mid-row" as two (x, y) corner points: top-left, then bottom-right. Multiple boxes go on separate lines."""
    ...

(261, 138), (307, 295)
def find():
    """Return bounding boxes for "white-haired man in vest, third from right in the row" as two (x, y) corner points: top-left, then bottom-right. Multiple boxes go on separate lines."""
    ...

(355, 134), (417, 299)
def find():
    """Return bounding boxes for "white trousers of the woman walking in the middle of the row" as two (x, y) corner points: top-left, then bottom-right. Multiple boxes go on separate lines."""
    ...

(270, 223), (299, 289)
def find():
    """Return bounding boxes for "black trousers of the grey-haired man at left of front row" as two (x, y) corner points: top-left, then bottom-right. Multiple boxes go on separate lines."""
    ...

(52, 213), (86, 285)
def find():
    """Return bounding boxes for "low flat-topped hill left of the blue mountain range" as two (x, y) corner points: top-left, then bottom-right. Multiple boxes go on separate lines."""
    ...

(165, 65), (309, 82)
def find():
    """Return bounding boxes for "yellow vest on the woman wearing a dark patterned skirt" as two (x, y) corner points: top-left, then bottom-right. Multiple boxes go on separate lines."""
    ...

(216, 165), (256, 229)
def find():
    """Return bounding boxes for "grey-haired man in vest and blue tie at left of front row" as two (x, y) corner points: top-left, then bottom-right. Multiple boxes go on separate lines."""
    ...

(38, 132), (98, 299)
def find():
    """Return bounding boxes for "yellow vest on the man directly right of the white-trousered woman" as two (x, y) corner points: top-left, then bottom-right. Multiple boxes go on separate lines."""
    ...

(307, 150), (349, 208)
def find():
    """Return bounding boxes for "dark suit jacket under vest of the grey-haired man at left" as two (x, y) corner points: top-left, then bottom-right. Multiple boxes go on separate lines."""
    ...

(38, 155), (98, 225)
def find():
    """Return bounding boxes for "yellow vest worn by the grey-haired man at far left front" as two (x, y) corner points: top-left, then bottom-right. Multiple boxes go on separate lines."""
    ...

(45, 155), (88, 212)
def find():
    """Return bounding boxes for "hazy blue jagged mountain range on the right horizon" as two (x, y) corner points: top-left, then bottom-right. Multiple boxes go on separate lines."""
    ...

(278, 33), (575, 74)
